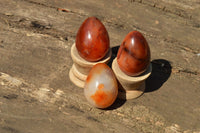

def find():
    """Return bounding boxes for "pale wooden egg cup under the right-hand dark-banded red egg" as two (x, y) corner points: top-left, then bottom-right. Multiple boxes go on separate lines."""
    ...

(112, 58), (152, 99)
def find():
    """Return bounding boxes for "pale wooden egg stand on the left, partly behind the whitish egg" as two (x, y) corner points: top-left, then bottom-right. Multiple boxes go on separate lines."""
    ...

(69, 44), (112, 88)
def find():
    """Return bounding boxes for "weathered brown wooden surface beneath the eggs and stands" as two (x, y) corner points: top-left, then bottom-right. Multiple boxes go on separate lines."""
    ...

(0, 0), (200, 133)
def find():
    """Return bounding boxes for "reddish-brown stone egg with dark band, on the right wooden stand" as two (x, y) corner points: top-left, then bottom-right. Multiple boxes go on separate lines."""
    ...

(117, 31), (150, 76)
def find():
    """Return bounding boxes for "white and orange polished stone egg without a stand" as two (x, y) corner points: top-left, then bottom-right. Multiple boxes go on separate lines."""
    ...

(84, 63), (118, 108)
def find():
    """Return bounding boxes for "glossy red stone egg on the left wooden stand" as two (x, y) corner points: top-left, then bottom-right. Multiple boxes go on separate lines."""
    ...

(76, 17), (110, 61)
